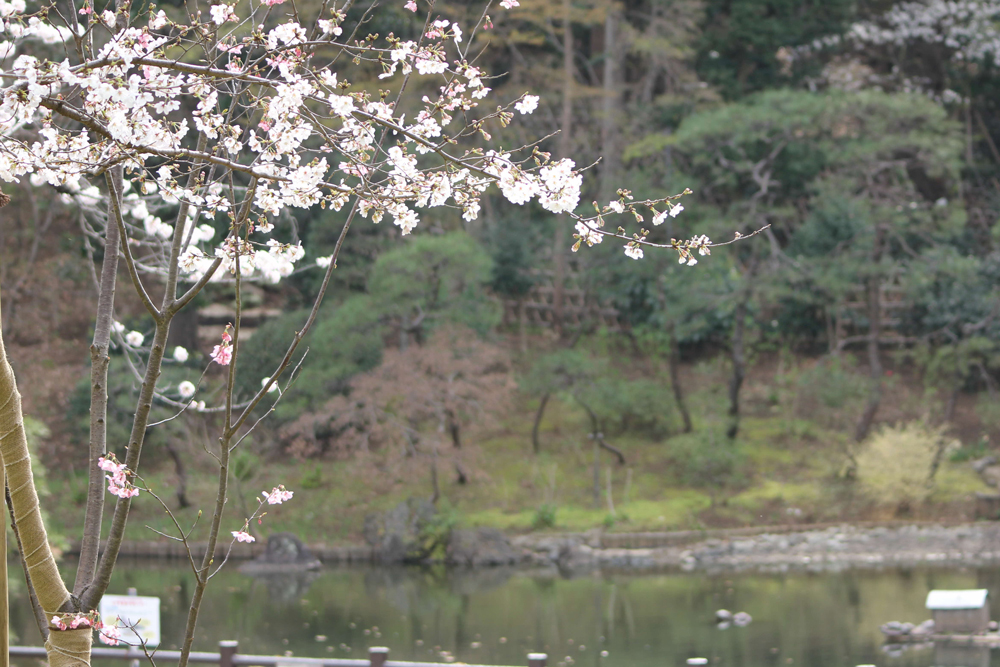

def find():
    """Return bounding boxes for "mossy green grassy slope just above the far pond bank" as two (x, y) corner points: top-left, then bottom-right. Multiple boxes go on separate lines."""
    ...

(41, 354), (987, 543)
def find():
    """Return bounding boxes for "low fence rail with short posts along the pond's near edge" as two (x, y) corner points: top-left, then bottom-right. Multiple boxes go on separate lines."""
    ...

(10, 641), (548, 667)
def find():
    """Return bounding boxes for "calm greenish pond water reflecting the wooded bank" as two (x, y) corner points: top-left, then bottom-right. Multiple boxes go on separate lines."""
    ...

(11, 561), (1000, 667)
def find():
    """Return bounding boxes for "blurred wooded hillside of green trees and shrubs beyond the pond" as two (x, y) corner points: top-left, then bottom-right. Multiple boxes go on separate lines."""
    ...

(23, 0), (1000, 532)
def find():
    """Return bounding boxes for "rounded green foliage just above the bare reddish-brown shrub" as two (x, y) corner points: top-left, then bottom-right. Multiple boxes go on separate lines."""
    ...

(237, 233), (500, 422)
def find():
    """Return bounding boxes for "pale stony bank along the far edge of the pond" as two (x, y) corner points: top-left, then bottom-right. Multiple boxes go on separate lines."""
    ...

(67, 522), (1000, 572)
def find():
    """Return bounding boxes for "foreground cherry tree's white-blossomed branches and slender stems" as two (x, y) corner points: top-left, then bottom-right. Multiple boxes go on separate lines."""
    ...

(0, 0), (712, 667)
